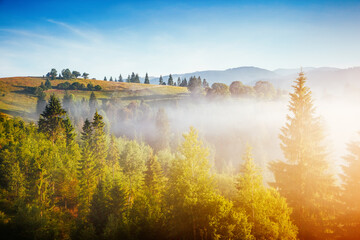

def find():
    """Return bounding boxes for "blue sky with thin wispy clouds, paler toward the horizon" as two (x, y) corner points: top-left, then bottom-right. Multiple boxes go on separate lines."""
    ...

(0, 0), (360, 79)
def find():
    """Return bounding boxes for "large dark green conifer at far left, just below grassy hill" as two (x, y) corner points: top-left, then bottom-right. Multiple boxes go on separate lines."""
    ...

(38, 94), (66, 141)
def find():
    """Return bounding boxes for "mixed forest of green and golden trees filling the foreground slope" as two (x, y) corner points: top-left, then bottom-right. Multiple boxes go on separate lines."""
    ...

(0, 72), (360, 239)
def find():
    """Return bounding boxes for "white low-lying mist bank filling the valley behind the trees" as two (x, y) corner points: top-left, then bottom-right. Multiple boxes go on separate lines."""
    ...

(47, 83), (360, 182)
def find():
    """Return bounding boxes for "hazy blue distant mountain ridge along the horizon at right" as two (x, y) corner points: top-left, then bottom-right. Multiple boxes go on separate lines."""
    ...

(150, 66), (360, 95)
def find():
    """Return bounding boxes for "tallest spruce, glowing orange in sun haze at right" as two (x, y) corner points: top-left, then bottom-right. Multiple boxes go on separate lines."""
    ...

(270, 72), (337, 239)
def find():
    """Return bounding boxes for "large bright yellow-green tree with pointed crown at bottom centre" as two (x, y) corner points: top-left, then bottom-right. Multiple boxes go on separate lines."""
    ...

(166, 128), (252, 239)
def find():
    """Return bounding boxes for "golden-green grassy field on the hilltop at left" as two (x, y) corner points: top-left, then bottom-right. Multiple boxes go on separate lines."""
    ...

(0, 77), (188, 120)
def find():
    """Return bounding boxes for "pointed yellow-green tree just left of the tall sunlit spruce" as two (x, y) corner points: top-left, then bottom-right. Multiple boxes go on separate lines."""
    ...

(236, 147), (297, 239)
